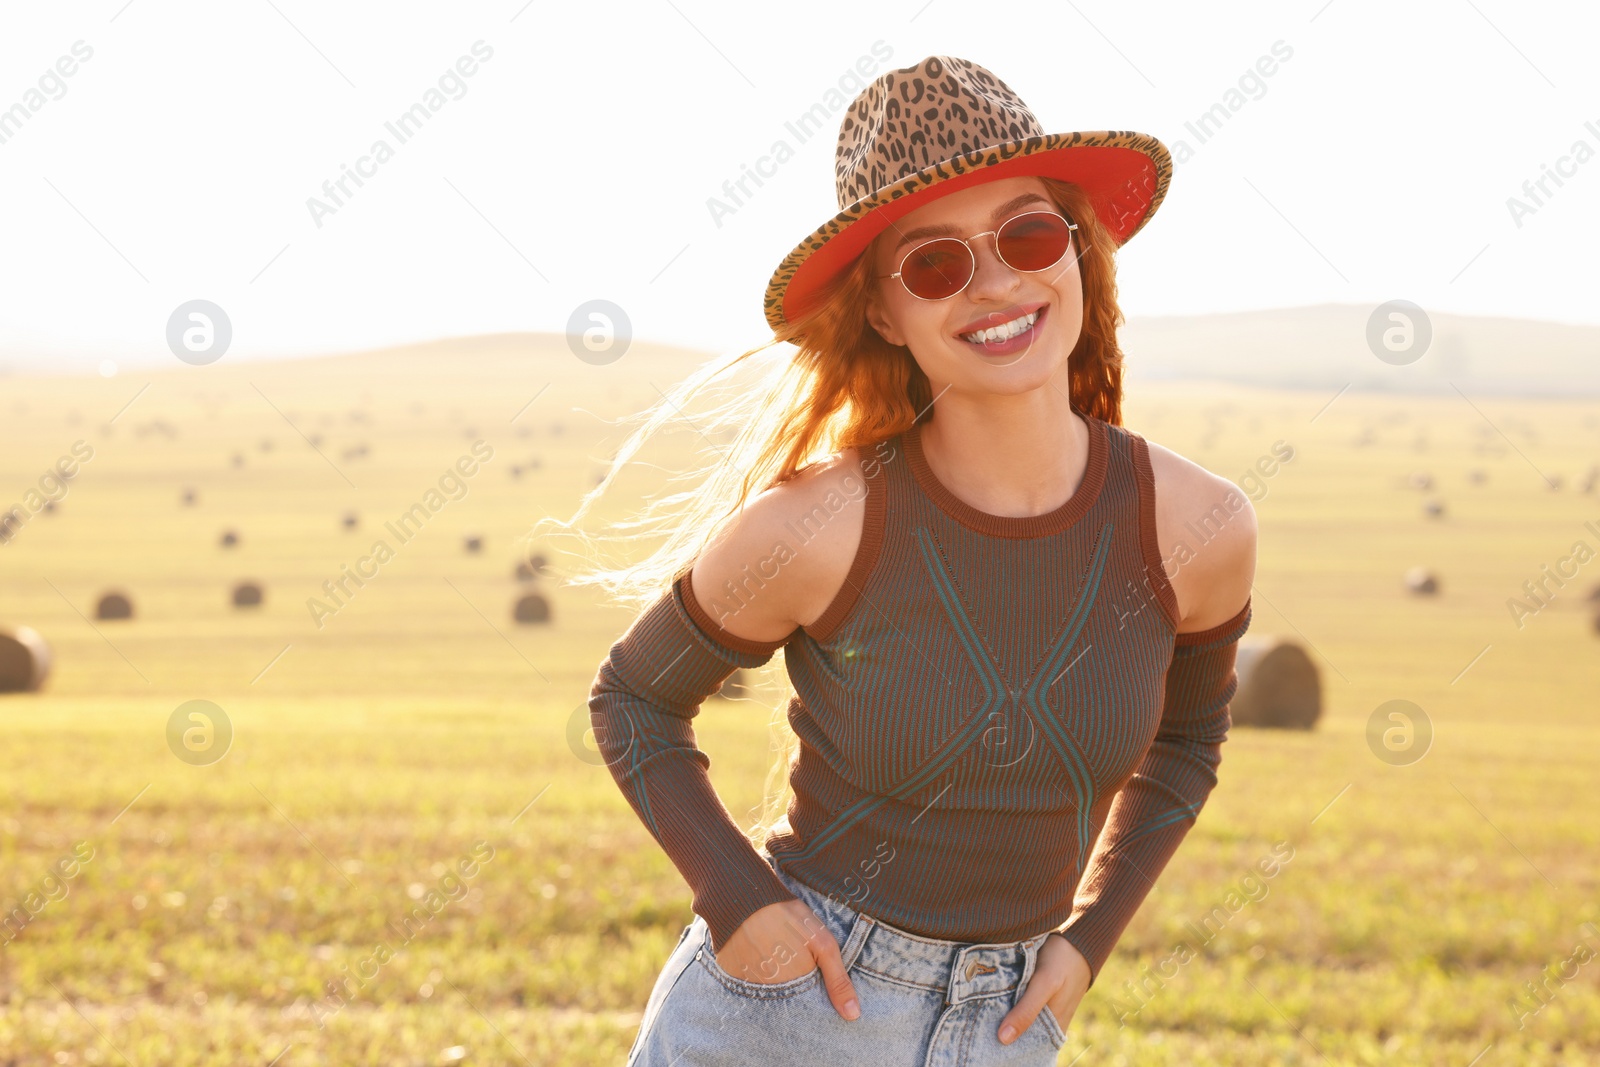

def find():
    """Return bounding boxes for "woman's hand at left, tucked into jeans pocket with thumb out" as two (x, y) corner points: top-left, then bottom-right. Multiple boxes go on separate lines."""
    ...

(714, 901), (861, 1019)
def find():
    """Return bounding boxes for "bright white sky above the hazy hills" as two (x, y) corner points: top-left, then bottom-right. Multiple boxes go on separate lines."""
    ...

(0, 0), (1600, 370)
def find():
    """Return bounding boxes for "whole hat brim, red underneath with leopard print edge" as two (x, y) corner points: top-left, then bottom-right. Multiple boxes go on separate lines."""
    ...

(763, 130), (1173, 330)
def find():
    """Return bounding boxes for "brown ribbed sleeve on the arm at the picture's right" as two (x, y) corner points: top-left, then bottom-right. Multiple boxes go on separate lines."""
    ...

(1059, 600), (1251, 987)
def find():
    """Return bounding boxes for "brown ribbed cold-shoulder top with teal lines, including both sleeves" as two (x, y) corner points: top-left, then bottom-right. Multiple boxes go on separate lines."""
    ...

(590, 418), (1251, 976)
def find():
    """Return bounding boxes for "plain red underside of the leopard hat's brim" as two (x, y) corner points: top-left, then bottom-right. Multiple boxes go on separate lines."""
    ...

(784, 144), (1157, 322)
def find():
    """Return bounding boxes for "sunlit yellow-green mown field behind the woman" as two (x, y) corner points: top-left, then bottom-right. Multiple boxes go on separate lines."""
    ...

(0, 338), (1600, 1067)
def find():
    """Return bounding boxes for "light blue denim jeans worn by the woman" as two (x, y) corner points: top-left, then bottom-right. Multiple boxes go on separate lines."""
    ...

(627, 856), (1067, 1067)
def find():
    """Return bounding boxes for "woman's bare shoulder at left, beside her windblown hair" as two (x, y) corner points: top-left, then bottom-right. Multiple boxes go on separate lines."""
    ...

(691, 448), (867, 641)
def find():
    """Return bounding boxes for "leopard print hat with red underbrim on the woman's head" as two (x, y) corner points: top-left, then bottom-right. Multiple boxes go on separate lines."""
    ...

(765, 56), (1173, 330)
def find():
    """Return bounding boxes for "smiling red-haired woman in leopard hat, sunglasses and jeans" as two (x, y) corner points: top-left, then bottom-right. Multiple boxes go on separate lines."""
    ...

(589, 56), (1256, 1067)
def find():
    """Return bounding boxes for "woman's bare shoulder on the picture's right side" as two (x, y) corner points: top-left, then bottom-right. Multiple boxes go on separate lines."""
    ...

(1146, 440), (1256, 633)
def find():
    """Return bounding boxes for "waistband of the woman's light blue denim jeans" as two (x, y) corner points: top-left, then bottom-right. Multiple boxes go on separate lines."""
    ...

(763, 854), (1050, 1005)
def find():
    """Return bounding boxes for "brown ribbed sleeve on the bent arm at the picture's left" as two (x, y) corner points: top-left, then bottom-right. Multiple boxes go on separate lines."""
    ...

(589, 573), (795, 950)
